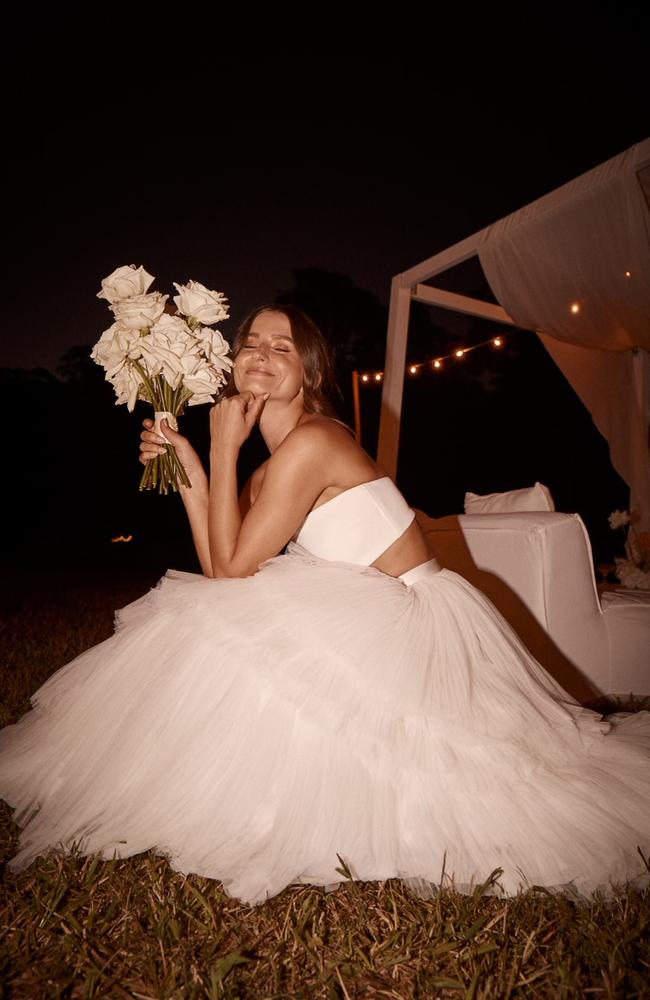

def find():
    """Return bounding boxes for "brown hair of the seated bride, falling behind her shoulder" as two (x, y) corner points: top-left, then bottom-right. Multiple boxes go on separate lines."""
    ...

(223, 304), (337, 417)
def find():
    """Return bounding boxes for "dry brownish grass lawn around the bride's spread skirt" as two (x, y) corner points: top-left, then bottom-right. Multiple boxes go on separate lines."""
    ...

(0, 573), (650, 1000)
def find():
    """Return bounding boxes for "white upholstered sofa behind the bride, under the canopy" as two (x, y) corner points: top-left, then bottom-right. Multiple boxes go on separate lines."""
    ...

(416, 511), (650, 704)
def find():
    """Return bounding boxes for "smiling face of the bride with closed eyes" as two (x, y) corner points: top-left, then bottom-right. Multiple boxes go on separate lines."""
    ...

(235, 312), (305, 401)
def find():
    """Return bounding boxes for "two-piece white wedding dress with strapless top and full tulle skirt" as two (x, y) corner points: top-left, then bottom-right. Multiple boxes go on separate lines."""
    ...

(0, 478), (650, 903)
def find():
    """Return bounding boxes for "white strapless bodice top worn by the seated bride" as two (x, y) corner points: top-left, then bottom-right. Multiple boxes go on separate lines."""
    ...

(296, 476), (415, 566)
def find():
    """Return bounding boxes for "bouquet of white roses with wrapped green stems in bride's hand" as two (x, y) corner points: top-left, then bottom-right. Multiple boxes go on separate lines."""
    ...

(91, 264), (232, 493)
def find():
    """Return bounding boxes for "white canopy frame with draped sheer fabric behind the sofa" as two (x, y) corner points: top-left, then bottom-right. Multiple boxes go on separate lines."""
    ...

(378, 139), (650, 530)
